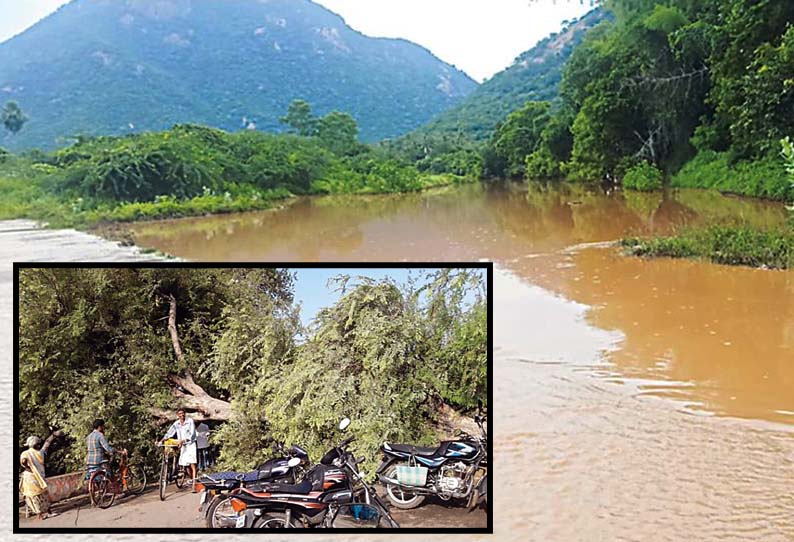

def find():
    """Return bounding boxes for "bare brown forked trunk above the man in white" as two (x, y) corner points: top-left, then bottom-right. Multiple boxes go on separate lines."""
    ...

(157, 294), (232, 421)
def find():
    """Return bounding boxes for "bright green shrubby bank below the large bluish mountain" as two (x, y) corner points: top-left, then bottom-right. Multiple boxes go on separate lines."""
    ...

(0, 125), (474, 227)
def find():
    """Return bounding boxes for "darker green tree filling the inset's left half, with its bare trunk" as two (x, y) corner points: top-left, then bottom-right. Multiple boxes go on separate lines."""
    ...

(18, 268), (291, 469)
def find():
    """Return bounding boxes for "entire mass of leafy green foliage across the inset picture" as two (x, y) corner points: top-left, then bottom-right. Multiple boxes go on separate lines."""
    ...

(17, 268), (487, 478)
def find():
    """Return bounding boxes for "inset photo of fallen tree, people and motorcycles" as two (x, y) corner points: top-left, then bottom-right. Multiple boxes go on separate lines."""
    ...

(14, 262), (493, 533)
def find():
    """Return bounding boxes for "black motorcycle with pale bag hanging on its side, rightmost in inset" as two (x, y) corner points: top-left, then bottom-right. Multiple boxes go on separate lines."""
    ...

(377, 403), (488, 510)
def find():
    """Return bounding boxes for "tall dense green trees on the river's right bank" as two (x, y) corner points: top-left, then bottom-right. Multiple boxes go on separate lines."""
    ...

(486, 0), (794, 200)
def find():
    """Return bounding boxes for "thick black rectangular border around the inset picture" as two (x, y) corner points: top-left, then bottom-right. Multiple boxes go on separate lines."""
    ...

(11, 261), (494, 536)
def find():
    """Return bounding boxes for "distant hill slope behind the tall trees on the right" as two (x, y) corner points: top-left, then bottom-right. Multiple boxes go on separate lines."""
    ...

(418, 8), (606, 139)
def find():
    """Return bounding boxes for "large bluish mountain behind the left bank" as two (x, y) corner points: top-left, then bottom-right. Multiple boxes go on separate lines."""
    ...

(0, 0), (477, 151)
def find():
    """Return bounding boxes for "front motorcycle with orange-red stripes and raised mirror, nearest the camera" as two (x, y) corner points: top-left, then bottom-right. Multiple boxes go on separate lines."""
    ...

(224, 418), (399, 529)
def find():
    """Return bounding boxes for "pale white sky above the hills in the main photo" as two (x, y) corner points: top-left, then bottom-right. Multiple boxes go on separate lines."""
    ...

(0, 0), (590, 81)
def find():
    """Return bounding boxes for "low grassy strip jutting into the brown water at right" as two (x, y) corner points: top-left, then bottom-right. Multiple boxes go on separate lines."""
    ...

(622, 226), (794, 269)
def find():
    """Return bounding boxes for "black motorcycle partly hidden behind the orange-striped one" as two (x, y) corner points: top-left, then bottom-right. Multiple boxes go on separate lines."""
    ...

(196, 445), (310, 528)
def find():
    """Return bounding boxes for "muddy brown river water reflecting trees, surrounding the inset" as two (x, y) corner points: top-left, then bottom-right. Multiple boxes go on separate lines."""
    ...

(125, 186), (794, 541)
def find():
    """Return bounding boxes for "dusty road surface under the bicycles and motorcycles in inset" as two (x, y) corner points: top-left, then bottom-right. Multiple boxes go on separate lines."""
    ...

(19, 486), (487, 530)
